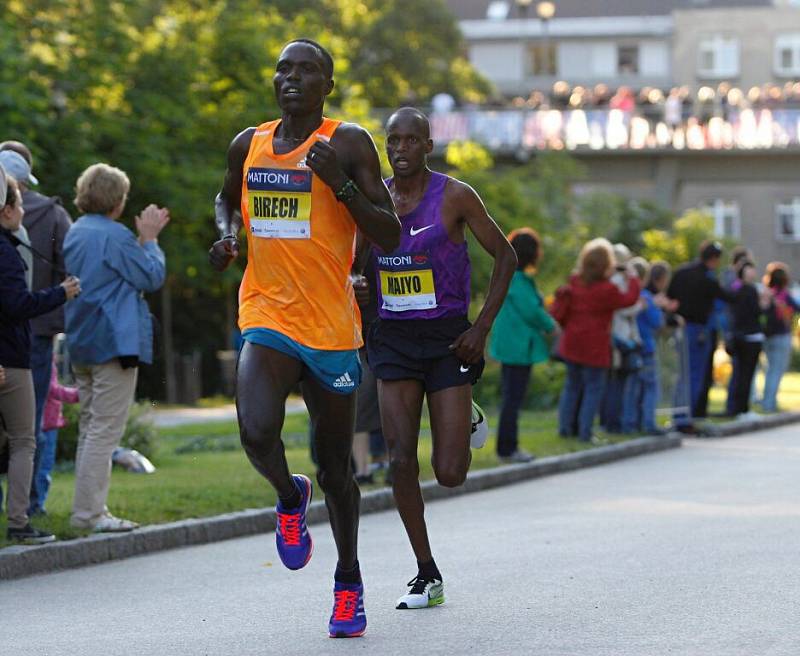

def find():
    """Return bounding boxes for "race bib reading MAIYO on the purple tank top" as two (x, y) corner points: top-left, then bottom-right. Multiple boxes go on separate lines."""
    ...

(377, 253), (436, 312)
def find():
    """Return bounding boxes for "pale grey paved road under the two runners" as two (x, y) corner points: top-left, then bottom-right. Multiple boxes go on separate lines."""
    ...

(6, 427), (800, 656)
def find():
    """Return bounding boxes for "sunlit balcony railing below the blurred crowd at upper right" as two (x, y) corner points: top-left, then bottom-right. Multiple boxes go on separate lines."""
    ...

(430, 109), (800, 156)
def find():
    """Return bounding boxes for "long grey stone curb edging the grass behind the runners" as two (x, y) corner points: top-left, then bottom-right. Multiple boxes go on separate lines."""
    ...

(0, 436), (680, 580)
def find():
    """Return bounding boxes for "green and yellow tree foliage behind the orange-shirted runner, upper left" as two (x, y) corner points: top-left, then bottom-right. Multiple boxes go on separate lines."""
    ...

(0, 0), (487, 397)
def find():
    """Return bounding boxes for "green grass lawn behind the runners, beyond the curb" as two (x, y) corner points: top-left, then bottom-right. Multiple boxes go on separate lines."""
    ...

(0, 373), (800, 546)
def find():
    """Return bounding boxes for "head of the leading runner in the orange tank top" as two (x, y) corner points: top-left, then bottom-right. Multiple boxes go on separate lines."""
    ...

(272, 43), (333, 114)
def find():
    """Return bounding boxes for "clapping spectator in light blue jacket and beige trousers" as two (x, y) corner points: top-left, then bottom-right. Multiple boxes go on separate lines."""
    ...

(64, 164), (169, 532)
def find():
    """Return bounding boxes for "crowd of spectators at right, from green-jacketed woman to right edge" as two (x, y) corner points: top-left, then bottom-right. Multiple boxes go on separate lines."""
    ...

(490, 229), (800, 448)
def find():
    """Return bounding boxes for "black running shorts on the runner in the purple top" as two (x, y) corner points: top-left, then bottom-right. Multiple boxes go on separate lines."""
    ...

(367, 317), (486, 392)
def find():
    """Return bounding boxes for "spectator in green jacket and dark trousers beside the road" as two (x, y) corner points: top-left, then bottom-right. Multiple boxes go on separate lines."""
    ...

(489, 228), (557, 462)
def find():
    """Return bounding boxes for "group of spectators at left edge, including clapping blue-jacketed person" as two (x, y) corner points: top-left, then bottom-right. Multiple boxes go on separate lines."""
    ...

(0, 141), (169, 543)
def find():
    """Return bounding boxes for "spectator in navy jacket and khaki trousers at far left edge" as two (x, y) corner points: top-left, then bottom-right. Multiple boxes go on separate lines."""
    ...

(0, 176), (80, 543)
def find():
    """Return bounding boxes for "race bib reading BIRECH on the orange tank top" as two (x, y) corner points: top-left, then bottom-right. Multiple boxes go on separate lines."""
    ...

(247, 167), (312, 239)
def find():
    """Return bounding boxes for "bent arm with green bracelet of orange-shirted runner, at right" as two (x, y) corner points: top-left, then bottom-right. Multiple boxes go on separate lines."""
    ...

(306, 123), (400, 252)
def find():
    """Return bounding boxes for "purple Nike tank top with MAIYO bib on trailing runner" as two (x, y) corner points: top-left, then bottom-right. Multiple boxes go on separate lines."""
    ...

(375, 172), (470, 319)
